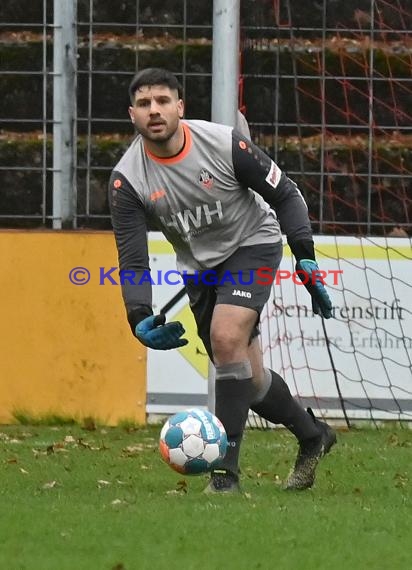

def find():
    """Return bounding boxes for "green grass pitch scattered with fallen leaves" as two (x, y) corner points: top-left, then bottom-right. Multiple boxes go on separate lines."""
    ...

(0, 425), (412, 570)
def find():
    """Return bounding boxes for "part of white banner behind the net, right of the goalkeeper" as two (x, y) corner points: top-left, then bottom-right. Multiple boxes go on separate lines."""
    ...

(261, 236), (412, 423)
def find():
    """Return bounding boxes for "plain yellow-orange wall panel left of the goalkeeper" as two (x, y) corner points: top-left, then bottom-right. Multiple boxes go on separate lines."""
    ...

(0, 231), (146, 425)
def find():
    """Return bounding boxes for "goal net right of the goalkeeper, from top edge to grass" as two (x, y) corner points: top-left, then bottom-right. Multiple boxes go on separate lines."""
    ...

(240, 0), (412, 424)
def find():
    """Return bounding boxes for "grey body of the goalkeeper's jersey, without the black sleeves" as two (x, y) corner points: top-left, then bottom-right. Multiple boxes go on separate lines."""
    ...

(115, 121), (281, 272)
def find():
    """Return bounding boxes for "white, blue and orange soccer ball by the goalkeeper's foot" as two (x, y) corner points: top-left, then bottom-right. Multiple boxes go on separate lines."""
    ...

(159, 408), (227, 475)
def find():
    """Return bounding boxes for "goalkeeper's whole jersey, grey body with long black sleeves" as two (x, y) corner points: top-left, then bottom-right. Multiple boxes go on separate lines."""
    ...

(109, 120), (312, 316)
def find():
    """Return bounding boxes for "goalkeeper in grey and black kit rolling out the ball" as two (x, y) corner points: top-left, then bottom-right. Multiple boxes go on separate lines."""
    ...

(109, 68), (336, 493)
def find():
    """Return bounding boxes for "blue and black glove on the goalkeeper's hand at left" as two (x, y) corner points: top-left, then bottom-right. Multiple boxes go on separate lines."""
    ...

(135, 315), (189, 350)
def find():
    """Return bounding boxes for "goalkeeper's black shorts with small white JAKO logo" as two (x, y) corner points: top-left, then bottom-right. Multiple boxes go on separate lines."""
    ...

(185, 242), (283, 359)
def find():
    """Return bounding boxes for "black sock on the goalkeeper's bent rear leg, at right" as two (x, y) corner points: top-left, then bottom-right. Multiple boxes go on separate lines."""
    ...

(251, 370), (320, 441)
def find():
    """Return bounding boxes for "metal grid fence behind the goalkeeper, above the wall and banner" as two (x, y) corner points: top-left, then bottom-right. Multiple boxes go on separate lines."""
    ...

(0, 0), (412, 234)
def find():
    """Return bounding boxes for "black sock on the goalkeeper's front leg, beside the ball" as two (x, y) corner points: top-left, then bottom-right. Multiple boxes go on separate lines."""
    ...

(215, 368), (254, 473)
